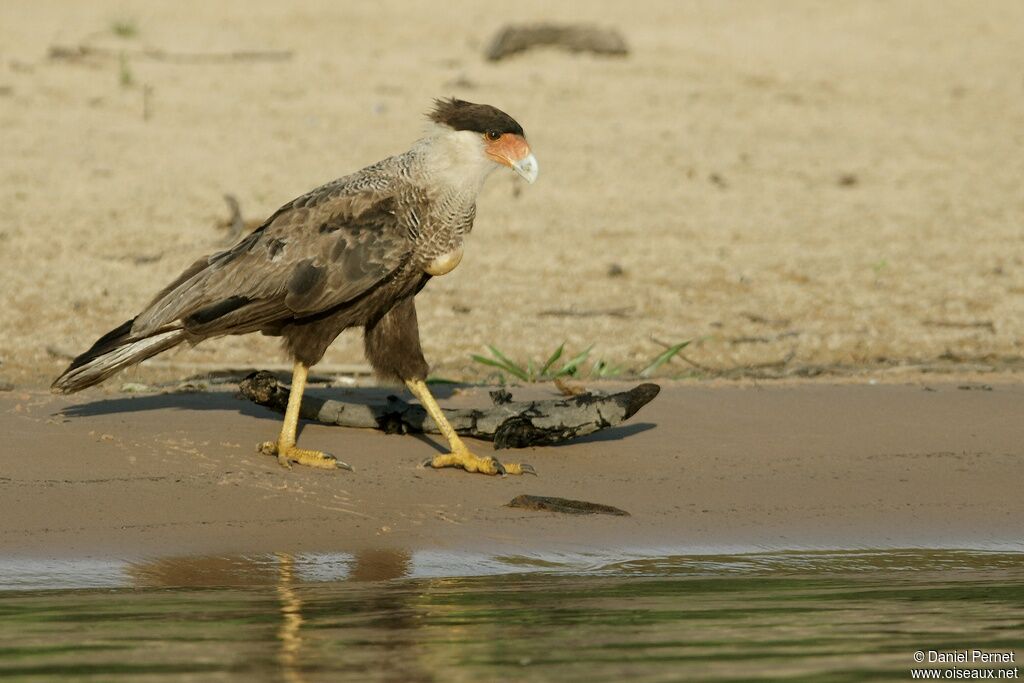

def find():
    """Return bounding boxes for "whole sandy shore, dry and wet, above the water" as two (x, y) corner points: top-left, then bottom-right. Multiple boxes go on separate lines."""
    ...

(0, 0), (1024, 556)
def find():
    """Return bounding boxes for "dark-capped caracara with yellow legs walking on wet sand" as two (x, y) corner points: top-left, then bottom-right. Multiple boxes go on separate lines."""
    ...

(52, 97), (539, 475)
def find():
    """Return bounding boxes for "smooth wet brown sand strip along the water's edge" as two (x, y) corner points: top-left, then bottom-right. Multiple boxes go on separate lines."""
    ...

(0, 383), (1024, 557)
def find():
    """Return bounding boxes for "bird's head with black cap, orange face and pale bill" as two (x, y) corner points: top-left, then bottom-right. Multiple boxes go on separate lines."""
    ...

(428, 97), (538, 182)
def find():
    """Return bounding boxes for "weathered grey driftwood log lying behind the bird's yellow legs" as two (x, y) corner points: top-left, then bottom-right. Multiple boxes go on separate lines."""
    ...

(239, 371), (660, 449)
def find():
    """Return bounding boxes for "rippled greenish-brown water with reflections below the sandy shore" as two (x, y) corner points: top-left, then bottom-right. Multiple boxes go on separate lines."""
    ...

(0, 551), (1024, 682)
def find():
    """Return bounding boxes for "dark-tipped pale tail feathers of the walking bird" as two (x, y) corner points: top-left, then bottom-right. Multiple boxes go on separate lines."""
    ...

(50, 321), (185, 393)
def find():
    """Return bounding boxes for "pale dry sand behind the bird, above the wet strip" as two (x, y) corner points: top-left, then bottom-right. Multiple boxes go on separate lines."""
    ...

(0, 0), (1024, 389)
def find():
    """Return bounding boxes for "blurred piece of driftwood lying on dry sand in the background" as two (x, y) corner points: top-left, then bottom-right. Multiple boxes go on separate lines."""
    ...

(485, 24), (630, 61)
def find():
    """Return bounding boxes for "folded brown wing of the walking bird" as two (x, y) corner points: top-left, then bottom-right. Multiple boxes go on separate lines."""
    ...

(132, 158), (416, 336)
